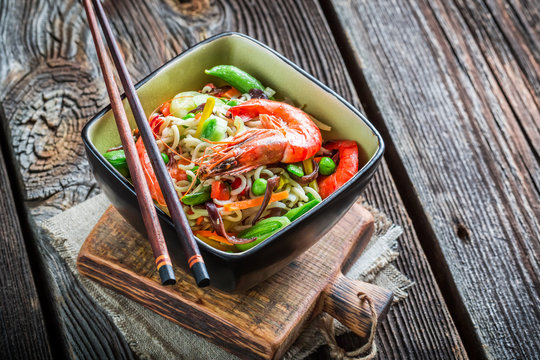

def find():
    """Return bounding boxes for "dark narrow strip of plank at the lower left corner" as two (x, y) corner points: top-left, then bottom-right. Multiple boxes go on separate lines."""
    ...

(0, 111), (51, 359)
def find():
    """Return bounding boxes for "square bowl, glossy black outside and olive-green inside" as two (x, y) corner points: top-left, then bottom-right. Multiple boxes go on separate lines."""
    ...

(82, 33), (384, 292)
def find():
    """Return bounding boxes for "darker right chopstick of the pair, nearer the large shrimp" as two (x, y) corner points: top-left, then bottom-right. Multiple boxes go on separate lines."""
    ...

(85, 0), (210, 287)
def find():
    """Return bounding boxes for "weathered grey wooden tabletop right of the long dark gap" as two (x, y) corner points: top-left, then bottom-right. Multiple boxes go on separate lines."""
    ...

(326, 0), (540, 359)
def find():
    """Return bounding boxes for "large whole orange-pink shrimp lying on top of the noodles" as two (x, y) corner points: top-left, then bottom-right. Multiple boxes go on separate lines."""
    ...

(200, 99), (322, 179)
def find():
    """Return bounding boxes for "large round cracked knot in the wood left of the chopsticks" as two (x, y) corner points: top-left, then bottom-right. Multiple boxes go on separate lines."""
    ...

(5, 59), (104, 200)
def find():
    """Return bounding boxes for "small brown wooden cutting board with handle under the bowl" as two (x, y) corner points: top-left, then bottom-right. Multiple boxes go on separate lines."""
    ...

(77, 204), (392, 359)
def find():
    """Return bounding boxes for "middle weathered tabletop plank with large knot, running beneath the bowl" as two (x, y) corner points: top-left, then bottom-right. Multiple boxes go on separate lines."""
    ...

(0, 0), (466, 359)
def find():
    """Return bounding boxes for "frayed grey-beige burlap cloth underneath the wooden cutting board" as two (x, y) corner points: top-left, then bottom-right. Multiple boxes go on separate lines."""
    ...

(41, 195), (412, 360)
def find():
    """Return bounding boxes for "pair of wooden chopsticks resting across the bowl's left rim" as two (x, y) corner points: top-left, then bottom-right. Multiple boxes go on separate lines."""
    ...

(83, 0), (210, 287)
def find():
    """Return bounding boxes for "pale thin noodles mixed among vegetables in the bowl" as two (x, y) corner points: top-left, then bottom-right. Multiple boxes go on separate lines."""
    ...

(150, 86), (321, 233)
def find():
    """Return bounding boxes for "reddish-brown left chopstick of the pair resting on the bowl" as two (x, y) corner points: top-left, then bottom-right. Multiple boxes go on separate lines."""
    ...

(84, 0), (176, 285)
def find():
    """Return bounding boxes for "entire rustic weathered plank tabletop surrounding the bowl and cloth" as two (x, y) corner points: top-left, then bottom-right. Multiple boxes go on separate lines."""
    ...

(0, 0), (540, 359)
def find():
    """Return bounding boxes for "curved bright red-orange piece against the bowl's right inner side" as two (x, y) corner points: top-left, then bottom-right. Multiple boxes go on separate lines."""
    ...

(317, 140), (358, 199)
